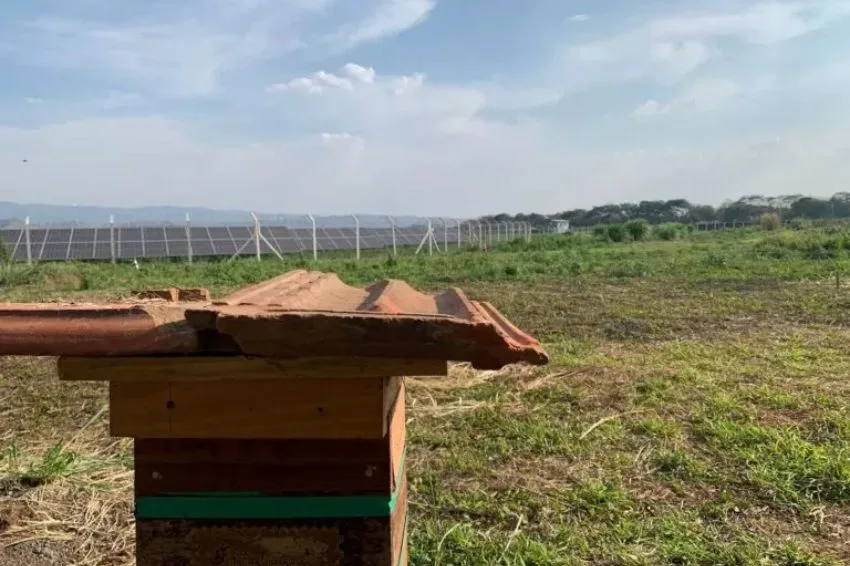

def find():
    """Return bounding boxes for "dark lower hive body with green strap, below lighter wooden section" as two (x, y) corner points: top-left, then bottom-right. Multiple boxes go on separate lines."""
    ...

(135, 380), (407, 566)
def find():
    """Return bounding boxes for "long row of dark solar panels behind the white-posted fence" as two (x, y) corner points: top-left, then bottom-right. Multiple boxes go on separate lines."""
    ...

(0, 226), (457, 261)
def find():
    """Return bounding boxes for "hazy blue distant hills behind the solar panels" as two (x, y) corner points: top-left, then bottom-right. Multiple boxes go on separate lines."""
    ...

(0, 201), (430, 228)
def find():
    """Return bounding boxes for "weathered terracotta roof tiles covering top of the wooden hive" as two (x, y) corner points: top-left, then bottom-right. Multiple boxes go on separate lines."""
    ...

(0, 271), (548, 369)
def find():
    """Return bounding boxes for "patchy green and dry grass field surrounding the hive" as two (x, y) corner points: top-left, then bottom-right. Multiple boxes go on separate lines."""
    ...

(0, 229), (850, 566)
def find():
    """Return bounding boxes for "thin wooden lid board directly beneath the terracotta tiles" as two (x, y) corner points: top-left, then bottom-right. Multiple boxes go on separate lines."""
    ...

(59, 356), (448, 382)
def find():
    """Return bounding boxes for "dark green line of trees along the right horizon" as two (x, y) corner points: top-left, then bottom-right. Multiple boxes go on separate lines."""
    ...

(481, 192), (850, 227)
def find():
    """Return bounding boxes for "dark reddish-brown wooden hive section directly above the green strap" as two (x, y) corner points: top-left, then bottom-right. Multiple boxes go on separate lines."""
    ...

(134, 390), (406, 497)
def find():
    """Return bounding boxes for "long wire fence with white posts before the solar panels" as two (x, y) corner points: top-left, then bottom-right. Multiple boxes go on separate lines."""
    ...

(0, 214), (532, 263)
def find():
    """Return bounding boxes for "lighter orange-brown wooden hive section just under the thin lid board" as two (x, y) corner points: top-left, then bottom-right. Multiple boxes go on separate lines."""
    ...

(110, 378), (400, 439)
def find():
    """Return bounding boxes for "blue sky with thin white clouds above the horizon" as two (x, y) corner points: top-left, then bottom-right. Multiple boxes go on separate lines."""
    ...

(0, 0), (850, 216)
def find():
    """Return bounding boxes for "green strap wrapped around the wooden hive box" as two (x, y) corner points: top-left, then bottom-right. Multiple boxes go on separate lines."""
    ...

(135, 447), (407, 520)
